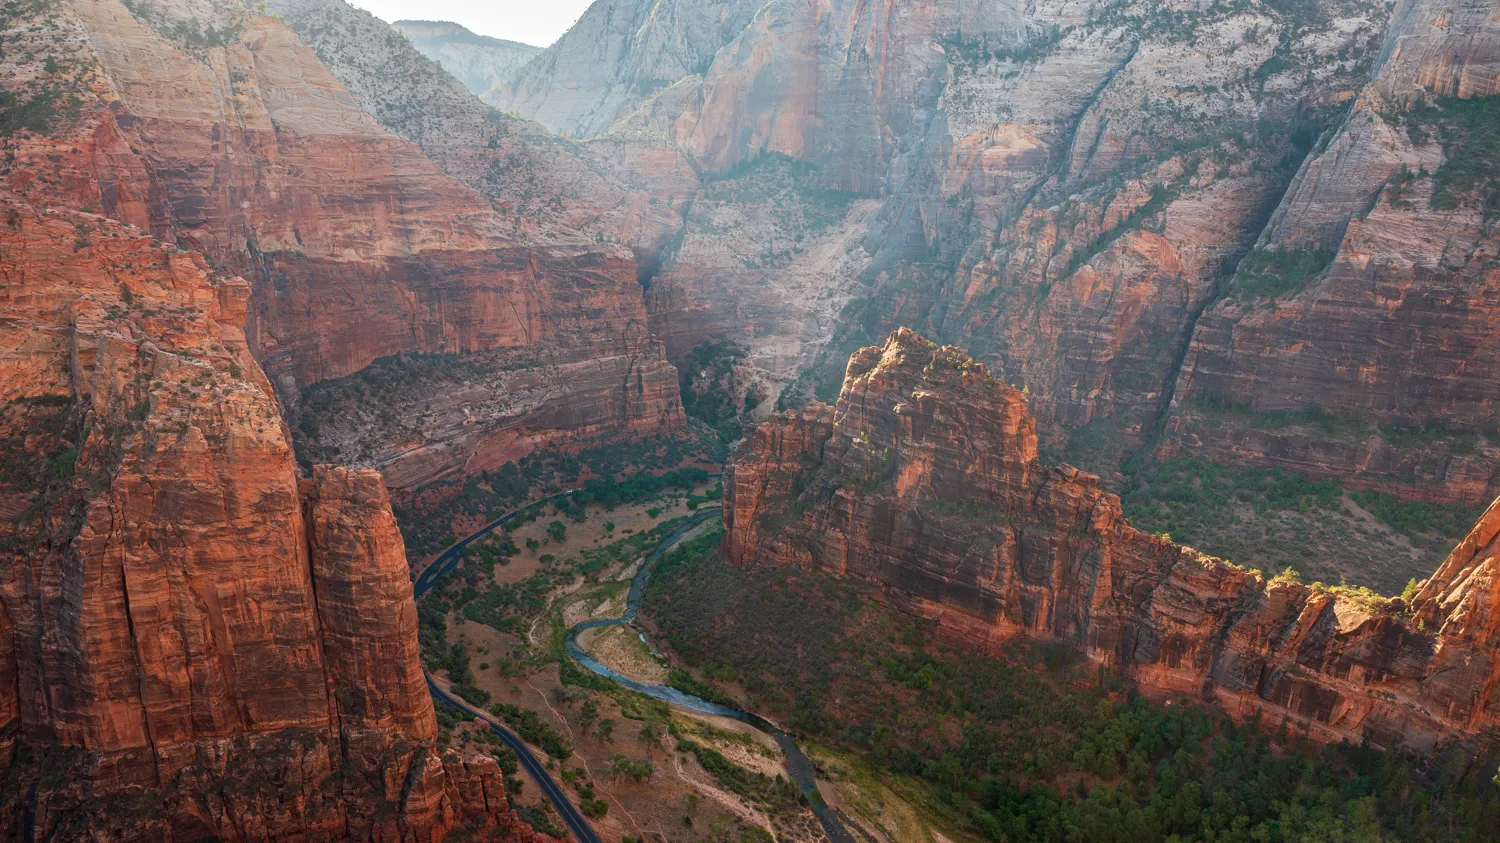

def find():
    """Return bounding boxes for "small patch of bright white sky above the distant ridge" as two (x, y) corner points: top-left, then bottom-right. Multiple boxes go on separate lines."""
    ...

(350, 0), (593, 47)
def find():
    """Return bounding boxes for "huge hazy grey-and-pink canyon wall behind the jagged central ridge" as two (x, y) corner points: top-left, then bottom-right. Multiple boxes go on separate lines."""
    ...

(480, 0), (1500, 503)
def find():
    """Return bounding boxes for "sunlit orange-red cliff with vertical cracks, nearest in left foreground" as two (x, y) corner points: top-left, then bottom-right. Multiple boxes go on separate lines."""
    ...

(0, 198), (530, 842)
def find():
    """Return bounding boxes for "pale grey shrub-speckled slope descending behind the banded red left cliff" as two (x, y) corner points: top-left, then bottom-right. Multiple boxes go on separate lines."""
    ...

(269, 0), (698, 255)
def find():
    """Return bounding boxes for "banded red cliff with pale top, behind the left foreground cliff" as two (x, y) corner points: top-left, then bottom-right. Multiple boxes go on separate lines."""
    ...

(5, 0), (681, 483)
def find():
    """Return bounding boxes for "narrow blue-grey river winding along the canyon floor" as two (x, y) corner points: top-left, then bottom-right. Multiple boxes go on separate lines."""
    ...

(564, 507), (855, 843)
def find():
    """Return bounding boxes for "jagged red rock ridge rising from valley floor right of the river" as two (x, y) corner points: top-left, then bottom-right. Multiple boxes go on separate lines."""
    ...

(725, 329), (1500, 750)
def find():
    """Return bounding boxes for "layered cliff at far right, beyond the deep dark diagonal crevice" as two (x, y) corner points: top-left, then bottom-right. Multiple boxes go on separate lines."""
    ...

(1169, 0), (1500, 501)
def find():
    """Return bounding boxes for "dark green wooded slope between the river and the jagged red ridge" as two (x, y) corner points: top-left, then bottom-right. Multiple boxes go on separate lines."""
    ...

(645, 542), (1500, 843)
